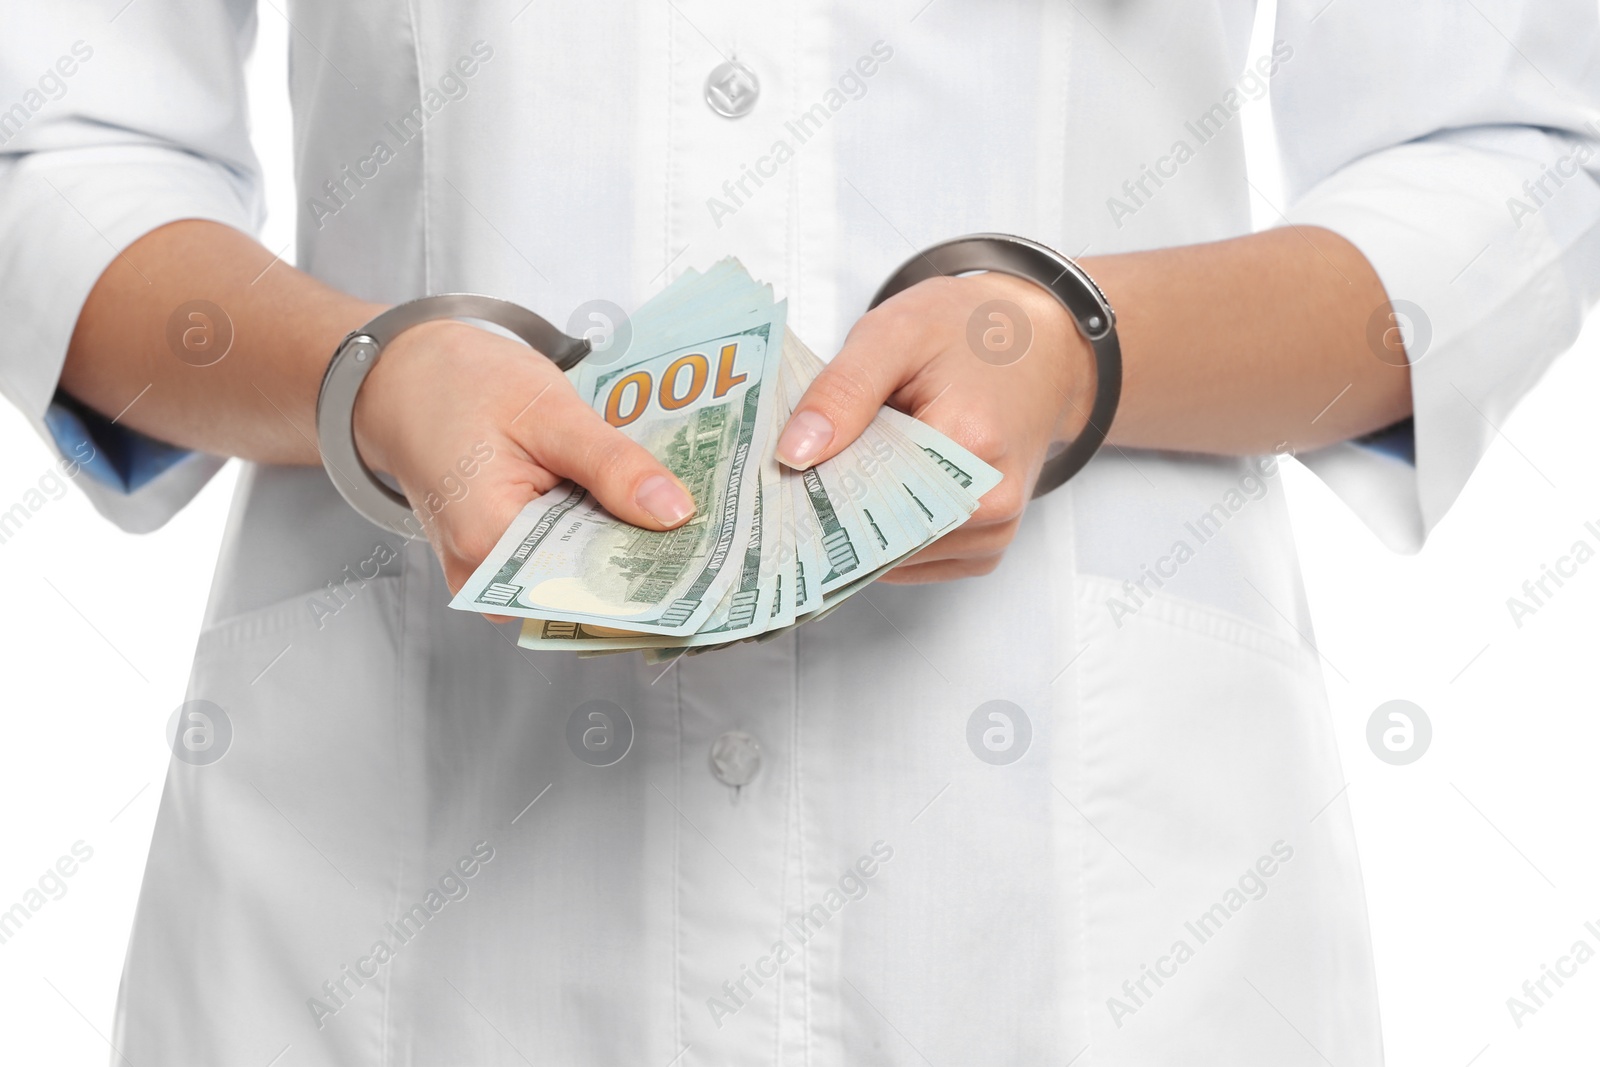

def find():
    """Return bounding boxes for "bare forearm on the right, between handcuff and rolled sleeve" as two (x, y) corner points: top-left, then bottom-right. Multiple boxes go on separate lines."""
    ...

(1088, 227), (1411, 454)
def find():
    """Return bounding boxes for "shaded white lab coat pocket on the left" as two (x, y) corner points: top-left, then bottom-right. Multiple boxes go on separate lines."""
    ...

(120, 574), (408, 1064)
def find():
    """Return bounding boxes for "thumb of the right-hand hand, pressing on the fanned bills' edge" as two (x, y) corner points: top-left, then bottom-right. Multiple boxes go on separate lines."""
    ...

(778, 320), (909, 470)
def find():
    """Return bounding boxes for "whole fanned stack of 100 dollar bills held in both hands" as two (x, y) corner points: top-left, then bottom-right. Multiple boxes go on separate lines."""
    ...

(451, 259), (1000, 662)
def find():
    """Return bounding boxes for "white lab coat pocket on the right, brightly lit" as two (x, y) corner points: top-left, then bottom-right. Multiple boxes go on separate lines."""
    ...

(1070, 576), (1381, 1064)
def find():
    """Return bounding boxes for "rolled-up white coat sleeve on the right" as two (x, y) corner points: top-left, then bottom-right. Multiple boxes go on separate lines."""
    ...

(1272, 0), (1600, 552)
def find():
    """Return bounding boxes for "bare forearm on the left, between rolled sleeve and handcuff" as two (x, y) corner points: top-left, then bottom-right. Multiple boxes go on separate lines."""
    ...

(61, 221), (382, 464)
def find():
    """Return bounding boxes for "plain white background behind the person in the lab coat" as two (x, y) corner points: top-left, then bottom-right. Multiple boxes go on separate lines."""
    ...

(0, 5), (1600, 1067)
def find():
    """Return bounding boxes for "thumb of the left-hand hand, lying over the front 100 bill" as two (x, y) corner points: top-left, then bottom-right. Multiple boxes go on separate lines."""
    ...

(530, 397), (694, 530)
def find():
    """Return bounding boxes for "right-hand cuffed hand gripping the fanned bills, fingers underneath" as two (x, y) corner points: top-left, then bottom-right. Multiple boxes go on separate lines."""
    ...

(778, 274), (1094, 582)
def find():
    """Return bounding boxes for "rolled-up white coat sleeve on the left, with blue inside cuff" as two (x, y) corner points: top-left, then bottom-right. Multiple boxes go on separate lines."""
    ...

(0, 0), (264, 533)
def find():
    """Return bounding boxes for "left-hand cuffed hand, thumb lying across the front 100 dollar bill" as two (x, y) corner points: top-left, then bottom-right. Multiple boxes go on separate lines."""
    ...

(355, 320), (694, 607)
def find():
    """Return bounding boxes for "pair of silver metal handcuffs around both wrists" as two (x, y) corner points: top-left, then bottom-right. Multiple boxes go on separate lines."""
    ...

(317, 234), (1122, 537)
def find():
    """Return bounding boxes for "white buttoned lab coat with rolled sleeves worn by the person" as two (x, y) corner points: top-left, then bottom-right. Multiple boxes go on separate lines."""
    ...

(0, 0), (1600, 1067)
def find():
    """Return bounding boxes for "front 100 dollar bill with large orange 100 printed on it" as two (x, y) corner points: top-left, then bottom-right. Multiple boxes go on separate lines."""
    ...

(451, 304), (784, 635)
